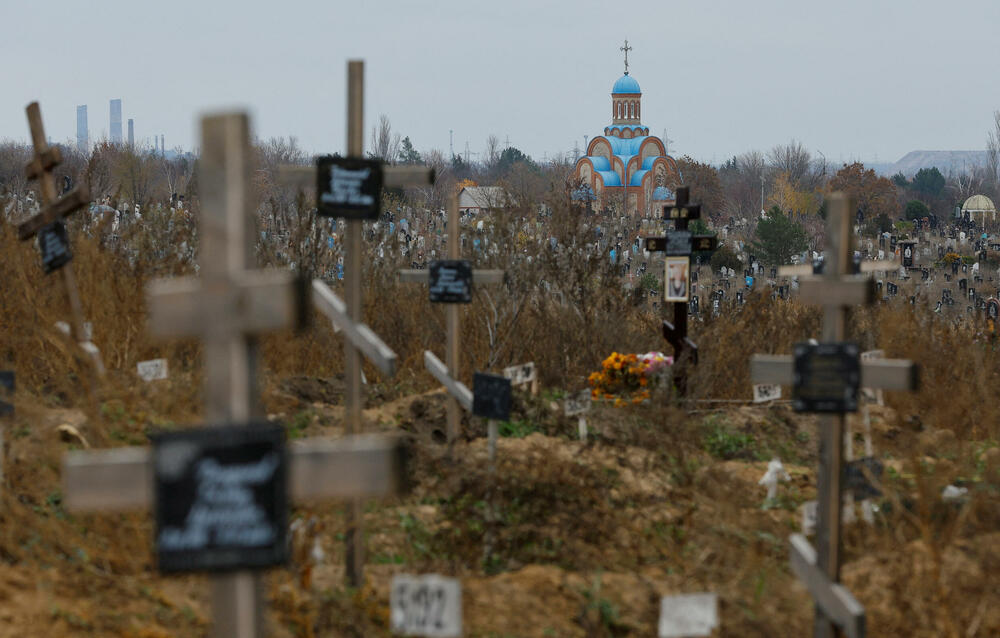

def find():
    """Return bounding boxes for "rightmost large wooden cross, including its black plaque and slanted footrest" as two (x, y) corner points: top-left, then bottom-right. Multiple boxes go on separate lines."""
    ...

(750, 193), (917, 638)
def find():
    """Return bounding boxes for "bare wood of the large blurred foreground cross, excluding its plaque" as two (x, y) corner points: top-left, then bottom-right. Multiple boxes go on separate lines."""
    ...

(63, 113), (402, 638)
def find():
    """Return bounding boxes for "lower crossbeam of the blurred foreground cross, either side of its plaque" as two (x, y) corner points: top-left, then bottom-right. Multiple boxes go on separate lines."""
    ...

(62, 435), (408, 512)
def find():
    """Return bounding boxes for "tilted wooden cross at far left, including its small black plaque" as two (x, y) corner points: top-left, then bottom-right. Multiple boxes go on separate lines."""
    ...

(17, 102), (104, 376)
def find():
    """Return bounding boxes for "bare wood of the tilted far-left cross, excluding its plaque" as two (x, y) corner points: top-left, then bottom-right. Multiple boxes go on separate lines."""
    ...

(17, 102), (104, 378)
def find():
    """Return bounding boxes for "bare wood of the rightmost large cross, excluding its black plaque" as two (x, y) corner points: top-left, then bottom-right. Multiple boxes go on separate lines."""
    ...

(750, 192), (917, 638)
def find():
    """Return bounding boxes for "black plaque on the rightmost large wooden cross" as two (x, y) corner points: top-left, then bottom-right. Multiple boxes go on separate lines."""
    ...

(792, 343), (861, 413)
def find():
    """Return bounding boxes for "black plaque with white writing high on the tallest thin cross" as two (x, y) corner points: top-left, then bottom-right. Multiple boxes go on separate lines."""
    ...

(316, 155), (382, 220)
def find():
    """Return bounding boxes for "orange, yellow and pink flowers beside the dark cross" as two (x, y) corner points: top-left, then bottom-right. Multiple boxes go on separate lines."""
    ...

(587, 352), (674, 407)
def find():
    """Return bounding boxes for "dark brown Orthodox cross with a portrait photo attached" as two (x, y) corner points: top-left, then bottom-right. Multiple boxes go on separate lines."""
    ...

(646, 186), (718, 396)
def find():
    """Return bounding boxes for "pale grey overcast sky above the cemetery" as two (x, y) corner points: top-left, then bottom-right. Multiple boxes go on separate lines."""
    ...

(0, 0), (1000, 163)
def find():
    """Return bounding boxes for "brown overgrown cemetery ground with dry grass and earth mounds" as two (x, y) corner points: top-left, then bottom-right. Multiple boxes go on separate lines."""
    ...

(0, 219), (1000, 638)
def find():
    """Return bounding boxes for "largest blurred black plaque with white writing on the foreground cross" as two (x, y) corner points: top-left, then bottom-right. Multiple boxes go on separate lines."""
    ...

(150, 423), (288, 573)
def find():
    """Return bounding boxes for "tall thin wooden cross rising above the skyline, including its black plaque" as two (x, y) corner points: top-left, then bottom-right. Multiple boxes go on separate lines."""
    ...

(281, 60), (434, 587)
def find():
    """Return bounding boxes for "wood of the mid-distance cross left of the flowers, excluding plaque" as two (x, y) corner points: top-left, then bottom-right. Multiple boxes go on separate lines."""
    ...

(399, 193), (504, 458)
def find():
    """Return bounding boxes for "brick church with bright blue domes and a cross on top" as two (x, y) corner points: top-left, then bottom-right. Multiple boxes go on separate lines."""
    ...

(572, 40), (681, 217)
